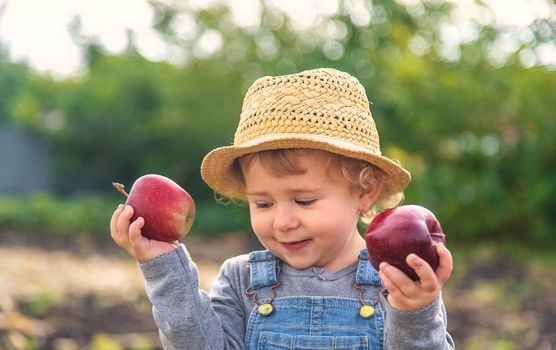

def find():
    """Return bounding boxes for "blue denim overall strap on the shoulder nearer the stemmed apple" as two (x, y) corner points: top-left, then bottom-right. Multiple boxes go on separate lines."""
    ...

(248, 250), (279, 290)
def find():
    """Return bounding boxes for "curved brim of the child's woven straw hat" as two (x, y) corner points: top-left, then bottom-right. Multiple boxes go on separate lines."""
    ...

(201, 134), (411, 200)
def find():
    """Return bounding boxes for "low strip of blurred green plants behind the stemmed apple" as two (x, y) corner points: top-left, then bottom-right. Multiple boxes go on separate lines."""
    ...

(0, 193), (249, 235)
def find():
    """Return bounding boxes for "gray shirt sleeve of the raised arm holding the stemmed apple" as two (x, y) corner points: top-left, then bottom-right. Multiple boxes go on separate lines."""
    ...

(139, 245), (245, 350)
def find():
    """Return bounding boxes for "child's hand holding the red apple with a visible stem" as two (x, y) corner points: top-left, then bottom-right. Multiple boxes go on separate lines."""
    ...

(110, 204), (178, 261)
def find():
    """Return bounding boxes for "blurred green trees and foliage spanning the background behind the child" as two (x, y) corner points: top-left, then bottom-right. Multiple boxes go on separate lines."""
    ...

(0, 0), (556, 245)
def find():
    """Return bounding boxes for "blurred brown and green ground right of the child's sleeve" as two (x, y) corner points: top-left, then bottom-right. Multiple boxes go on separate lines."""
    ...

(444, 242), (556, 350)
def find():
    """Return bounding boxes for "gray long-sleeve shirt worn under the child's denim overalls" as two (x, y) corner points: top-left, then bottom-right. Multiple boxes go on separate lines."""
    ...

(139, 245), (454, 350)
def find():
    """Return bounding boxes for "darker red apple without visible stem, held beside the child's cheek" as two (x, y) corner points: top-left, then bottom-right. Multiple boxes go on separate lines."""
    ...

(365, 205), (446, 281)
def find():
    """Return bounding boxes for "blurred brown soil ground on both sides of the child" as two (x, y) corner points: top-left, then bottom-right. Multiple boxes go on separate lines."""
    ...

(0, 232), (556, 350)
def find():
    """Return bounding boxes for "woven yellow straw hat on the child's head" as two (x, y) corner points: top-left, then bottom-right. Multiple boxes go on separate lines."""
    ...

(201, 68), (411, 199)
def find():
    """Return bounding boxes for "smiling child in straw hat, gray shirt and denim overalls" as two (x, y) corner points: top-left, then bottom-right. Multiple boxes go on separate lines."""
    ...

(111, 69), (454, 350)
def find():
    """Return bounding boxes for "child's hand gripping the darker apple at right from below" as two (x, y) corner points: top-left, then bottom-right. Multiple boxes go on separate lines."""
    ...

(379, 244), (453, 311)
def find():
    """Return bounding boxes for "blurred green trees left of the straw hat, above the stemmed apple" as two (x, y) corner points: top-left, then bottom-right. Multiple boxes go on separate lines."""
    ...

(7, 55), (242, 196)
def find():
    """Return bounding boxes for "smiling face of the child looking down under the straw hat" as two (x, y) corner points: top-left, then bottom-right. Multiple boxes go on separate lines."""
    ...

(243, 150), (365, 271)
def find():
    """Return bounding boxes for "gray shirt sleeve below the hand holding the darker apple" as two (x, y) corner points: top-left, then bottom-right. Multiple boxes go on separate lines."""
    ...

(383, 296), (455, 350)
